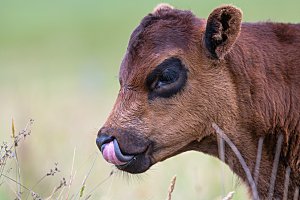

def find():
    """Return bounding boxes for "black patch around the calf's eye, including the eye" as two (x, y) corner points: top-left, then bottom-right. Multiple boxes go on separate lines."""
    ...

(146, 57), (187, 99)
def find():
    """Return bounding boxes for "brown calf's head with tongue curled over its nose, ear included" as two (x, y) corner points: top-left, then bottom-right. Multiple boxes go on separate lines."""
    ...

(96, 5), (241, 173)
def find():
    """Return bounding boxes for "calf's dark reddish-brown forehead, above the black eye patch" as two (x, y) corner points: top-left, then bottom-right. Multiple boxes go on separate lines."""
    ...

(119, 9), (202, 85)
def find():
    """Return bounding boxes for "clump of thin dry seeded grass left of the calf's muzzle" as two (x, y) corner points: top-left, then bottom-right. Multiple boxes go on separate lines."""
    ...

(0, 120), (114, 200)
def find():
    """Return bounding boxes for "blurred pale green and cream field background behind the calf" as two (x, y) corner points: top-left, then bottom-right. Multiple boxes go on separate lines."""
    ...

(0, 0), (300, 200)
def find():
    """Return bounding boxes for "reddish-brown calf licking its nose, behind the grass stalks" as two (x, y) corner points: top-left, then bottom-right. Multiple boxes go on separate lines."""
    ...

(97, 5), (300, 199)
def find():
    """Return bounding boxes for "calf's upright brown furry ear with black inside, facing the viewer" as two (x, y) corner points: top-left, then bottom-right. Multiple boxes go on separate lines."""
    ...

(204, 6), (242, 59)
